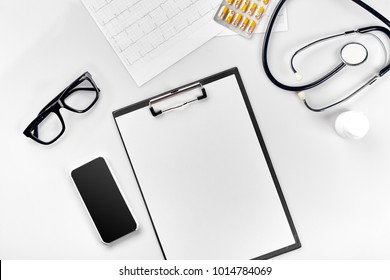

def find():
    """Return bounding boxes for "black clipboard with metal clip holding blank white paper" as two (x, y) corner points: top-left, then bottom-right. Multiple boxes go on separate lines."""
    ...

(113, 68), (301, 260)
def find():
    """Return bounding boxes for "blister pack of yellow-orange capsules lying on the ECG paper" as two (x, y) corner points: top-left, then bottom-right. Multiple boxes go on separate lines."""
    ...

(214, 0), (270, 38)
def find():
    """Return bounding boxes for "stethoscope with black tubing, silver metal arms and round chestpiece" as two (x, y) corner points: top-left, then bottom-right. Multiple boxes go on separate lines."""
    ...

(262, 0), (390, 112)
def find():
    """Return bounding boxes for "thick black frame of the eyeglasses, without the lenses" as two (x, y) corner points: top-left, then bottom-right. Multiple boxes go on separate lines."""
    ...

(23, 71), (100, 145)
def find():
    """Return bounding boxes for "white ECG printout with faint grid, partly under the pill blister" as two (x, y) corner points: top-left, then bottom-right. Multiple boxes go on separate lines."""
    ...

(81, 0), (285, 86)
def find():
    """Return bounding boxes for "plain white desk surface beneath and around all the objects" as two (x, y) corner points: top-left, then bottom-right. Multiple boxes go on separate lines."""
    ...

(0, 0), (390, 259)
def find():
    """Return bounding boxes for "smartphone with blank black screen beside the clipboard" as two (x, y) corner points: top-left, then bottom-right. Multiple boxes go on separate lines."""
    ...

(71, 157), (138, 244)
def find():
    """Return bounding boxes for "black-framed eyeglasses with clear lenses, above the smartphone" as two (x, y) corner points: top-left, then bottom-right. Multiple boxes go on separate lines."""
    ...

(23, 72), (100, 145)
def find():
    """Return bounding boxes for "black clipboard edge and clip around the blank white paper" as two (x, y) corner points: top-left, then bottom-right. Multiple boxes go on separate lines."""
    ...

(113, 68), (301, 259)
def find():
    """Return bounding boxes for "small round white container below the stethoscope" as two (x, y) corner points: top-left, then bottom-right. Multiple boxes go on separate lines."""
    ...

(335, 111), (370, 139)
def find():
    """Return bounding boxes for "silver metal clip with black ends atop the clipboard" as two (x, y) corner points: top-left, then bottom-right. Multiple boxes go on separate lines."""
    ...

(149, 83), (207, 117)
